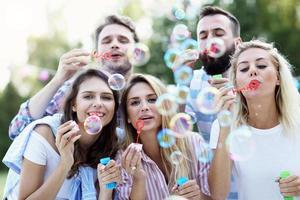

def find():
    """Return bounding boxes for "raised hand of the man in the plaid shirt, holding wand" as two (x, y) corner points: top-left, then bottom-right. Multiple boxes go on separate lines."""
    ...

(53, 49), (91, 82)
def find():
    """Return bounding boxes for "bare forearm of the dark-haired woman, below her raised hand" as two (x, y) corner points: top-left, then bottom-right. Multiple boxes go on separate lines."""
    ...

(19, 164), (69, 200)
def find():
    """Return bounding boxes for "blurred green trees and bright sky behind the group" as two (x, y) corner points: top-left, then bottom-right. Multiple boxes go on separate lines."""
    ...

(0, 0), (300, 196)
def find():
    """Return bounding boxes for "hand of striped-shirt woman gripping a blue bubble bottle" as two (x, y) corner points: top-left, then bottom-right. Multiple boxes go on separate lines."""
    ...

(171, 180), (201, 200)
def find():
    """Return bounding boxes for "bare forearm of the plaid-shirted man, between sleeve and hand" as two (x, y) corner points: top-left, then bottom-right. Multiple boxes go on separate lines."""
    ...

(29, 79), (63, 119)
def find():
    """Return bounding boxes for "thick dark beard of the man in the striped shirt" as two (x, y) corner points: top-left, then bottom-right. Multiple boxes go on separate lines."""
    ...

(200, 44), (235, 75)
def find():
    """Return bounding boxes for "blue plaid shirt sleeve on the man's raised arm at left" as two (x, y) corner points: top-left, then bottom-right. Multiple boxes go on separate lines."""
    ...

(8, 80), (72, 140)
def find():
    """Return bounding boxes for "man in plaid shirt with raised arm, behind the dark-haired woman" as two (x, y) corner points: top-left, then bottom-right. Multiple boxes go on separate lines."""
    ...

(9, 15), (139, 139)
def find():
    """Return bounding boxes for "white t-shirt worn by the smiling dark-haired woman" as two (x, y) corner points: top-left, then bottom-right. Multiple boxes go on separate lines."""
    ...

(8, 131), (72, 200)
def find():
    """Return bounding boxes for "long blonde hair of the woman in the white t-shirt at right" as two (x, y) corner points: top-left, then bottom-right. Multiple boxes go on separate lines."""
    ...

(229, 40), (300, 134)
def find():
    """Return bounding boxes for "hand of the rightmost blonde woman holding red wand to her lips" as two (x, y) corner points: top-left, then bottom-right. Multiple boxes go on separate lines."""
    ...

(215, 87), (236, 112)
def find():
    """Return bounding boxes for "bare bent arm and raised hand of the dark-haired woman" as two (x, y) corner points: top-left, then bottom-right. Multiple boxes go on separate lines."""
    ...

(19, 122), (80, 199)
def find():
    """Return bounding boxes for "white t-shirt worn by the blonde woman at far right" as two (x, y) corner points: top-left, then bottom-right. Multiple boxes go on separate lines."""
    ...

(210, 120), (300, 200)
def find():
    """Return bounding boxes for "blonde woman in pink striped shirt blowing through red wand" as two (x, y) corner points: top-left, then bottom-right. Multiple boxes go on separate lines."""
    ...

(117, 74), (209, 200)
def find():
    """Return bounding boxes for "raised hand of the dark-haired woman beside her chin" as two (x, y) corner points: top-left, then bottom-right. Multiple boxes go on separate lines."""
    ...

(55, 121), (81, 170)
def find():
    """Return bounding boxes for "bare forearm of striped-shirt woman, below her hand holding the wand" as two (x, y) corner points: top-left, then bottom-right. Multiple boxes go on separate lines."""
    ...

(130, 178), (146, 200)
